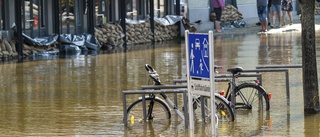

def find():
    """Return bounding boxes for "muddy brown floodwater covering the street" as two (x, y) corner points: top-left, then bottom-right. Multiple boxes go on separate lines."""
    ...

(0, 32), (320, 137)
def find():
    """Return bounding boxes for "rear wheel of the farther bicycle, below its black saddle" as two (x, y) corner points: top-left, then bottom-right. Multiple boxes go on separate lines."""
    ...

(232, 83), (270, 110)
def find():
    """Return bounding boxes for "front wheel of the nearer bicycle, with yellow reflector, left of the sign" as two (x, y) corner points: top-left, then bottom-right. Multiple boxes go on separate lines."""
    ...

(126, 98), (171, 131)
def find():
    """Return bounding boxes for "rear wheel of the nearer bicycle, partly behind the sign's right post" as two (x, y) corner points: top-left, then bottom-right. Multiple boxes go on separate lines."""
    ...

(193, 94), (234, 122)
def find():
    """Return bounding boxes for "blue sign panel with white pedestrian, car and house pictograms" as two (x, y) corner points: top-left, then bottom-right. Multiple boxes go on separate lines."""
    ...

(188, 34), (210, 79)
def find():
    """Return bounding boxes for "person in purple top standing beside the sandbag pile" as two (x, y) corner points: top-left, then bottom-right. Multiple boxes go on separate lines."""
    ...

(212, 0), (225, 32)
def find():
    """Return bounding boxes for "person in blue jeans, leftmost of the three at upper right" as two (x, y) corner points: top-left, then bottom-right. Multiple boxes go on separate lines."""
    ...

(257, 0), (268, 32)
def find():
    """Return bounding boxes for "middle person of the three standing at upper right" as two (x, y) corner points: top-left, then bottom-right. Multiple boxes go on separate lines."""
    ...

(270, 0), (282, 28)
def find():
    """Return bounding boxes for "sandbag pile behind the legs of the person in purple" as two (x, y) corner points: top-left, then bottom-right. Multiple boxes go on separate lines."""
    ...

(210, 5), (243, 22)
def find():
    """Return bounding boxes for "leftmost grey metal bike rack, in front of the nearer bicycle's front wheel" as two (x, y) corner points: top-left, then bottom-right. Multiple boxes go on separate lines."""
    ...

(122, 89), (188, 128)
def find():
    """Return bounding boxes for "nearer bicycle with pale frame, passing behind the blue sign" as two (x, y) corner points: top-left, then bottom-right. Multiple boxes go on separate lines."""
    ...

(126, 64), (234, 129)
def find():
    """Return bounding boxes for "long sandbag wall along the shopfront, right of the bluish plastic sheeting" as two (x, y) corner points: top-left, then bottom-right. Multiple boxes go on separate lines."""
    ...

(95, 22), (179, 46)
